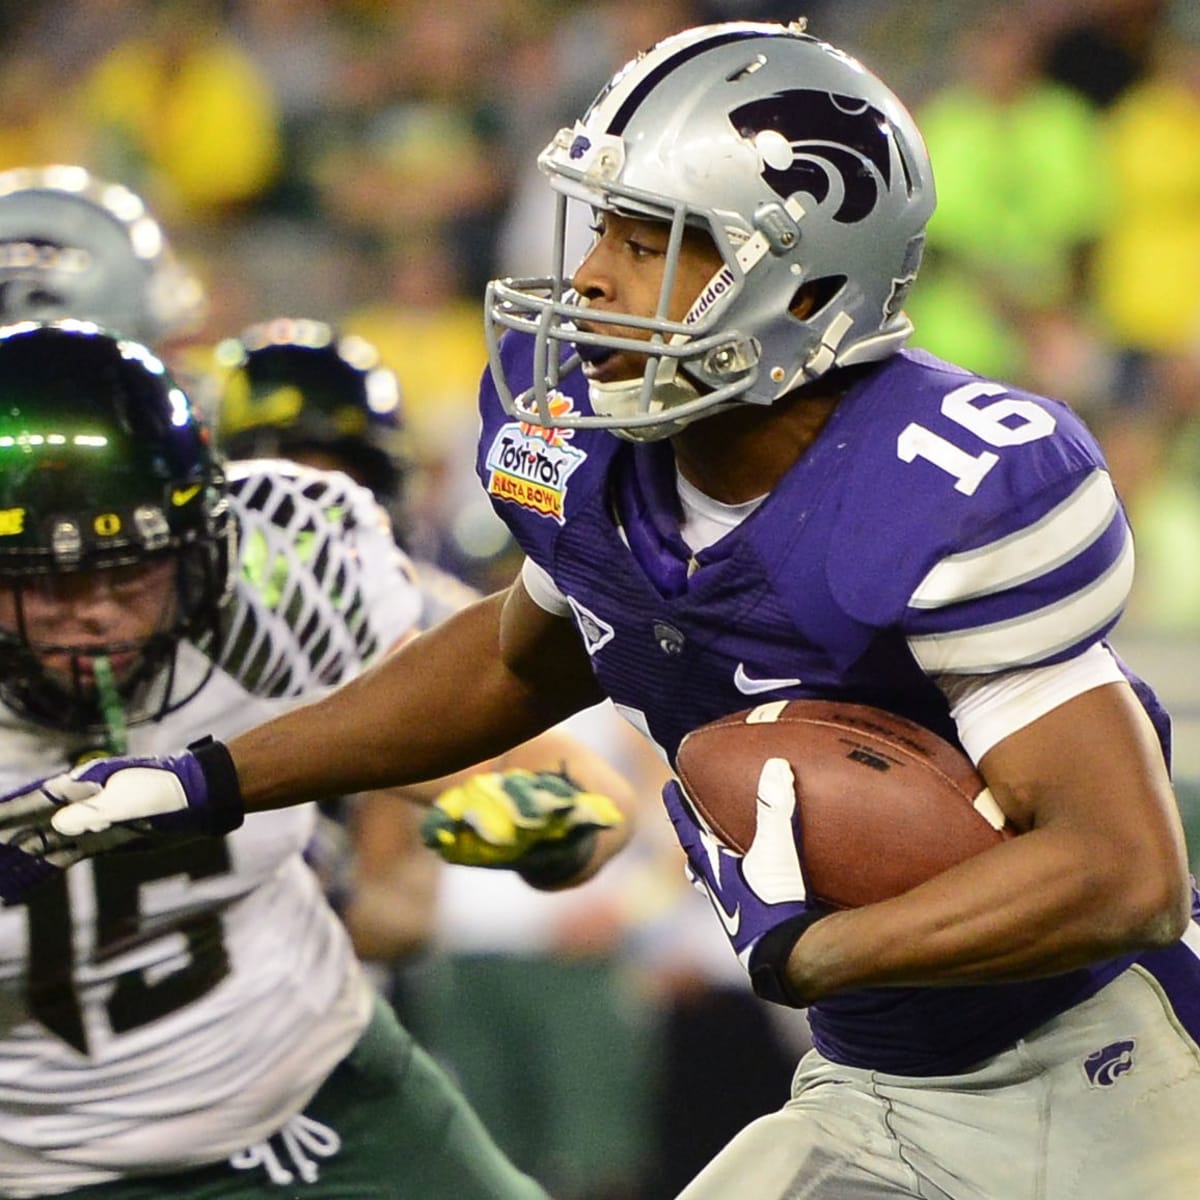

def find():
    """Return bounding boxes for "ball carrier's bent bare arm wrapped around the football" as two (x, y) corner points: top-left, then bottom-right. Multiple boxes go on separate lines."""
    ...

(787, 683), (1190, 1003)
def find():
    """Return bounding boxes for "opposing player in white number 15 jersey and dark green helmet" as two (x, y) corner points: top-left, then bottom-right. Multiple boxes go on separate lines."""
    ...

(0, 322), (628, 1200)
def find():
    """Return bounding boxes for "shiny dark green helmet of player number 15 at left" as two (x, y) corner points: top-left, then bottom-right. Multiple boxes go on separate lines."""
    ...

(0, 320), (234, 733)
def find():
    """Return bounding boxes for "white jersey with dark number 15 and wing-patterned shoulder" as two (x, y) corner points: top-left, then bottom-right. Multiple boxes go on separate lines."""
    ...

(0, 461), (420, 1198)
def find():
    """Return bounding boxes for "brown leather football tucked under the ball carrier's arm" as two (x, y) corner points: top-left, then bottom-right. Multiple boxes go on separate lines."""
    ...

(676, 700), (1013, 908)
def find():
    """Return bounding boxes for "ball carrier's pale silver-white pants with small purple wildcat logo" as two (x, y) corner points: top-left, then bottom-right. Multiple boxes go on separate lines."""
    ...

(679, 967), (1200, 1200)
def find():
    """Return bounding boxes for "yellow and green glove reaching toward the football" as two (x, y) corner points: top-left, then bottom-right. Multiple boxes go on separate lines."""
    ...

(421, 768), (625, 888)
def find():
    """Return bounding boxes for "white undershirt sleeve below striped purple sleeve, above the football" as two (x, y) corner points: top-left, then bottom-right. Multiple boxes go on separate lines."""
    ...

(936, 643), (1124, 763)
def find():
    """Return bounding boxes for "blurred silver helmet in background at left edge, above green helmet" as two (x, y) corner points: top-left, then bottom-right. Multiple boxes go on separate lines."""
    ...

(0, 166), (205, 344)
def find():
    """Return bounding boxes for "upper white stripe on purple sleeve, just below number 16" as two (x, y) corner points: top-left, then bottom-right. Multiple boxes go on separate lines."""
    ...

(908, 470), (1118, 608)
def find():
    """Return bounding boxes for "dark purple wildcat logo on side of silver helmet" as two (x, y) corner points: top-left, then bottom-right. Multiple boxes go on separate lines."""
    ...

(730, 88), (892, 224)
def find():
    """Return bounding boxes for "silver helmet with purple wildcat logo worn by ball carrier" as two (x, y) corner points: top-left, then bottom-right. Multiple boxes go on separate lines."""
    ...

(486, 22), (934, 440)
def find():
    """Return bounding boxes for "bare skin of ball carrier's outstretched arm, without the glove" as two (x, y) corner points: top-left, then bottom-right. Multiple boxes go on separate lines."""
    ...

(228, 596), (585, 811)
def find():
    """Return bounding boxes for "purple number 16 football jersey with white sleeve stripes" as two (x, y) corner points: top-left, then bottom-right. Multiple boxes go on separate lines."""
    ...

(478, 335), (1195, 1074)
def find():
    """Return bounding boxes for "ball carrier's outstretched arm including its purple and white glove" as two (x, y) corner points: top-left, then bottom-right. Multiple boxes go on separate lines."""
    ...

(18, 581), (601, 859)
